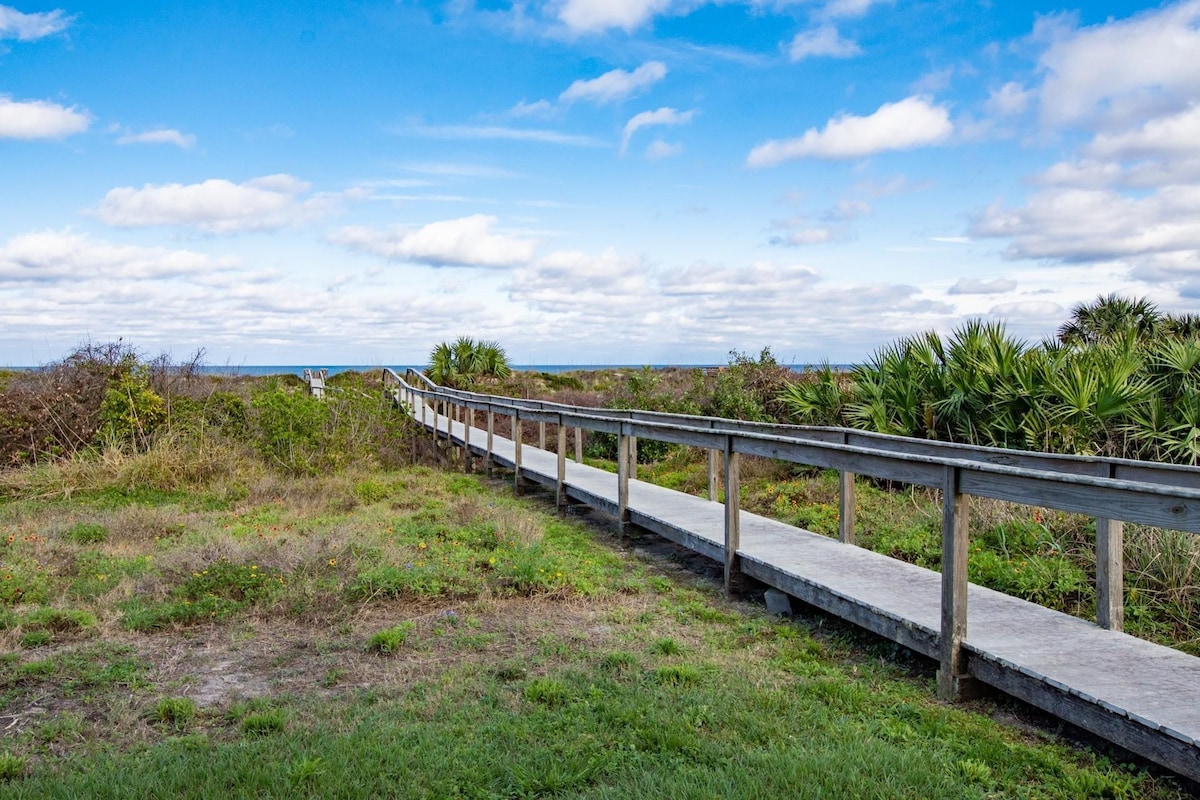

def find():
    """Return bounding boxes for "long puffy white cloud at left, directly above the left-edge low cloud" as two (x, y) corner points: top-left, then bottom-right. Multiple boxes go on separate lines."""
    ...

(91, 174), (337, 233)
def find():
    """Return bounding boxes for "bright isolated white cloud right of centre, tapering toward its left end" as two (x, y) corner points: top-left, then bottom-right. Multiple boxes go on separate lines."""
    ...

(746, 96), (954, 167)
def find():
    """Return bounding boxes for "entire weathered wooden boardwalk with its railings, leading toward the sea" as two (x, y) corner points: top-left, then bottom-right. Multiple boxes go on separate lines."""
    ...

(384, 371), (1200, 781)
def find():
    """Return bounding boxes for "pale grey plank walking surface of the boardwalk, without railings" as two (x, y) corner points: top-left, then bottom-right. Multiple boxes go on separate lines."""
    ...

(424, 407), (1200, 781)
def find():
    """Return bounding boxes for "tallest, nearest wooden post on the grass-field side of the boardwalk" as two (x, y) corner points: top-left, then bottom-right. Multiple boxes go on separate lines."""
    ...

(937, 467), (979, 702)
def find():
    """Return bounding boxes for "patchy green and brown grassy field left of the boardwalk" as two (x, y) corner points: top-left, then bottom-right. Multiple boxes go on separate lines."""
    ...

(0, 447), (1184, 798)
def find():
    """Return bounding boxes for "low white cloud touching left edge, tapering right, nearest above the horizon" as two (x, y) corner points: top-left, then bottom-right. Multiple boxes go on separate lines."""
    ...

(0, 230), (234, 283)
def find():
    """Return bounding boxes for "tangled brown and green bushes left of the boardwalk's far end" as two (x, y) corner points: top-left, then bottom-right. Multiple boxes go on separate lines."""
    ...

(0, 343), (408, 474)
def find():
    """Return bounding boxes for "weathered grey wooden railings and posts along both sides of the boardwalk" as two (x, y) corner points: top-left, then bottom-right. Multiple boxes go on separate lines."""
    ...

(384, 369), (1200, 699)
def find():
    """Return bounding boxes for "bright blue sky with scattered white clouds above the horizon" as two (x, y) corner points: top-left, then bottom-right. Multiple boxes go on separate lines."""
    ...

(0, 0), (1200, 365)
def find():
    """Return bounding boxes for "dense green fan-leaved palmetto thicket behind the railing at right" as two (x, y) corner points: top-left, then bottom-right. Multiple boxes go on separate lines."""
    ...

(780, 296), (1200, 464)
